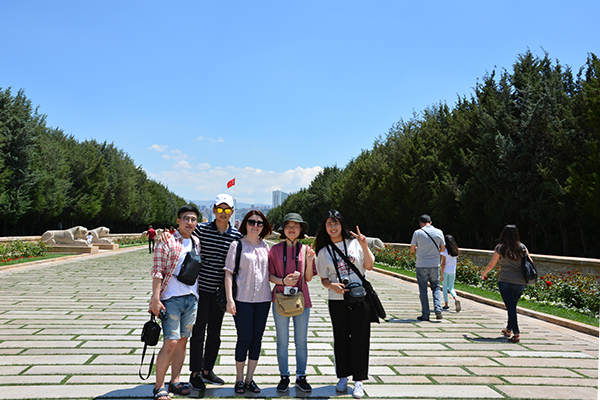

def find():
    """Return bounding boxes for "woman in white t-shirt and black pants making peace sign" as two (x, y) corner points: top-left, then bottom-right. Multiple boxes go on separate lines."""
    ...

(315, 210), (375, 398)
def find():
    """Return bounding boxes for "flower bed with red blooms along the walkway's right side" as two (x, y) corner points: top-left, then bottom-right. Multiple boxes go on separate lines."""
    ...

(373, 246), (600, 318)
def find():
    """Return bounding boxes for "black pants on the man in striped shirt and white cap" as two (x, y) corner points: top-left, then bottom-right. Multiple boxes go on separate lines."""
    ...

(190, 290), (225, 372)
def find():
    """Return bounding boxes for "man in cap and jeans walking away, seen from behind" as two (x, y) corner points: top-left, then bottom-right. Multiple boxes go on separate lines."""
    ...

(410, 214), (446, 321)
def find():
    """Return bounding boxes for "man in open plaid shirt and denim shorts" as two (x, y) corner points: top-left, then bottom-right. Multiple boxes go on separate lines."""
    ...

(150, 206), (200, 400)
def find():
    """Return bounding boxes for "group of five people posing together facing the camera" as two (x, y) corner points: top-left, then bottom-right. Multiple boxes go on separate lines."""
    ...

(150, 194), (374, 400)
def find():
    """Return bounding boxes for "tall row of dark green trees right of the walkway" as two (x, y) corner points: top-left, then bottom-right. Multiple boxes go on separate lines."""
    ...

(268, 52), (600, 257)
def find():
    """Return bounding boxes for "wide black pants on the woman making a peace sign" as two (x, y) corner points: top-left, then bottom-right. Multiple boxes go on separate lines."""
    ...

(329, 300), (371, 381)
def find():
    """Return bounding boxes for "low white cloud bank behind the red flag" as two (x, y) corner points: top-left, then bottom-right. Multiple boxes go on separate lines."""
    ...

(149, 164), (323, 204)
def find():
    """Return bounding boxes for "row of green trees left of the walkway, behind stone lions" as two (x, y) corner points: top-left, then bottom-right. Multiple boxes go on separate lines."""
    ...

(0, 88), (192, 236)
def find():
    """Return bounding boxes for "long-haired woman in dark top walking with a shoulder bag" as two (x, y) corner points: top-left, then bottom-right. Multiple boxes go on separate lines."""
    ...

(481, 225), (529, 343)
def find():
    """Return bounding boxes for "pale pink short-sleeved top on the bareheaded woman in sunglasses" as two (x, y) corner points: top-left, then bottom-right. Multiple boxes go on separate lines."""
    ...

(224, 240), (271, 303)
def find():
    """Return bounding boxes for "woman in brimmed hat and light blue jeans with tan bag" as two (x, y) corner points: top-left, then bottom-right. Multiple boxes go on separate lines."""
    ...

(269, 213), (317, 392)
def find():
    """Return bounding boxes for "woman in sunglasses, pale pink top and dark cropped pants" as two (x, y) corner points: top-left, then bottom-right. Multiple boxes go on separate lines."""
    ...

(225, 210), (271, 394)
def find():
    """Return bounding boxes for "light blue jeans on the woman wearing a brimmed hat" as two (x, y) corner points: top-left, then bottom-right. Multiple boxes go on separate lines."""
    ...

(273, 303), (310, 377)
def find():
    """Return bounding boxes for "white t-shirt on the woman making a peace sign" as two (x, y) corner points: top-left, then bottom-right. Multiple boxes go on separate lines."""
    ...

(317, 239), (371, 300)
